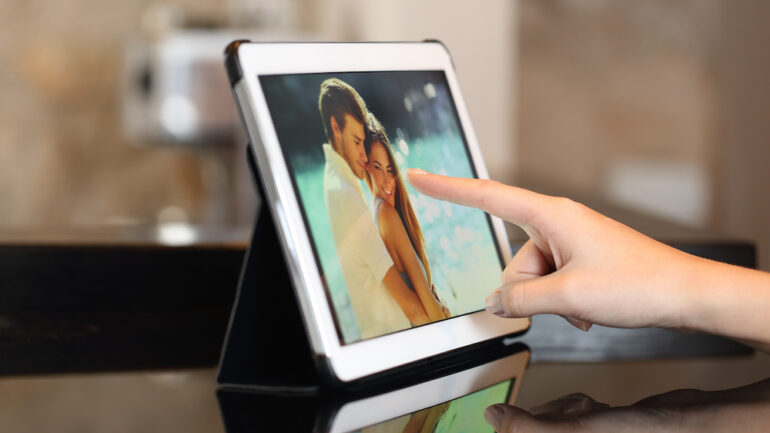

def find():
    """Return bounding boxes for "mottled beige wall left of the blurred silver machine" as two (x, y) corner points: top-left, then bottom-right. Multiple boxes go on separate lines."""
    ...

(0, 0), (244, 231)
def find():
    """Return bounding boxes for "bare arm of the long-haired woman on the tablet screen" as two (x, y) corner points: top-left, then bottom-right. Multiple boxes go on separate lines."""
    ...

(379, 206), (447, 322)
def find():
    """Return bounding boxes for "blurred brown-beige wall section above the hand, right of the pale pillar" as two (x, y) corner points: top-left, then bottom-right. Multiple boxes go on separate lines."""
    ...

(517, 0), (718, 228)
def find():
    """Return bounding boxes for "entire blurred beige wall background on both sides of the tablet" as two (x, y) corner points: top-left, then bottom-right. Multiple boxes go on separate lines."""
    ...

(0, 0), (770, 260)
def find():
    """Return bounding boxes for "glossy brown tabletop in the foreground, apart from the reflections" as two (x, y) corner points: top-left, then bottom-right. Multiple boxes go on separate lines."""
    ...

(0, 339), (770, 433)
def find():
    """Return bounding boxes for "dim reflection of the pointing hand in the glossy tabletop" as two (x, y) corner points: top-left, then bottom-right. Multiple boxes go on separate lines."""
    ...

(484, 379), (770, 433)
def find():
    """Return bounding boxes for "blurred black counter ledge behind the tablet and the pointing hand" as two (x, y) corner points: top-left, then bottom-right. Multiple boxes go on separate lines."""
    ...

(0, 219), (756, 375)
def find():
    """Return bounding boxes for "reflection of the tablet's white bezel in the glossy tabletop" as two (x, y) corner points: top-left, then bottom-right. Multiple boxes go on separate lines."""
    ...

(329, 351), (529, 433)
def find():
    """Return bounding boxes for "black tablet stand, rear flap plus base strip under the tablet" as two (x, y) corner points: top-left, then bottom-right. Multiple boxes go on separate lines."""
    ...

(217, 146), (526, 395)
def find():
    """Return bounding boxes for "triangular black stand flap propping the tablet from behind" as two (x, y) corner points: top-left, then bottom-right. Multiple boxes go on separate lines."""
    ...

(217, 146), (319, 393)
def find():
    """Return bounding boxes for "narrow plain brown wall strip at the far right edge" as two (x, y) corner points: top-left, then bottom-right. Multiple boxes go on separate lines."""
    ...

(716, 0), (770, 270)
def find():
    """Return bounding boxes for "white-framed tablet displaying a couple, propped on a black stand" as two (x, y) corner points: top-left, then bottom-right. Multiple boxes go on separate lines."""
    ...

(227, 43), (529, 381)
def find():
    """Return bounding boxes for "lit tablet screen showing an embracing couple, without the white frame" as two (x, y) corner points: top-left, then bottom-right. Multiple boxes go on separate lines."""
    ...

(259, 71), (502, 344)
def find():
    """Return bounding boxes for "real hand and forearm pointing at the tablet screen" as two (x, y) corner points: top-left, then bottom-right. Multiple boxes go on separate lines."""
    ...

(408, 170), (770, 343)
